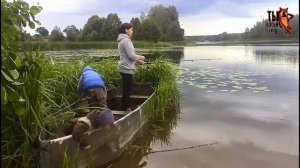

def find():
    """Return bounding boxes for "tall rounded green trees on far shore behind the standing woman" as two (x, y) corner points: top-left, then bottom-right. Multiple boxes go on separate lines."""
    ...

(19, 5), (184, 42)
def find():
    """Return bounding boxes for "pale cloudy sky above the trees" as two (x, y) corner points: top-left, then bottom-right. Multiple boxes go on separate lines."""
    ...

(25, 0), (299, 36)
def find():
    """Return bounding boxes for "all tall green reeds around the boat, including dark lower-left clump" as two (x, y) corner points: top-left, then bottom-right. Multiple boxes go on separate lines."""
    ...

(1, 53), (179, 167)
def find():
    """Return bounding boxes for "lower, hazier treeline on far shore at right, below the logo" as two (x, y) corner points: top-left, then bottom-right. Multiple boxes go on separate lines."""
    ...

(185, 15), (299, 42)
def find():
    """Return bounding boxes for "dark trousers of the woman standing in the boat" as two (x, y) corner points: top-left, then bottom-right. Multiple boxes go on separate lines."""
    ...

(120, 72), (133, 110)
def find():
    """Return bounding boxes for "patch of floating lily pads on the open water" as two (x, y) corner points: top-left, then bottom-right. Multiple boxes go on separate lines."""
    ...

(182, 66), (272, 93)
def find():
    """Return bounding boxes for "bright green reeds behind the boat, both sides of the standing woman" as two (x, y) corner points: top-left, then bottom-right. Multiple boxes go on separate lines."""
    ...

(41, 59), (179, 119)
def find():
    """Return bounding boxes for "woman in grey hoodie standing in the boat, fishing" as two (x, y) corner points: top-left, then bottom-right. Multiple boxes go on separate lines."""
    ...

(117, 23), (145, 112)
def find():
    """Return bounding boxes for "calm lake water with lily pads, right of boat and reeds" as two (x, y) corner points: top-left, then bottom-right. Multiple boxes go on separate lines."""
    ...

(100, 46), (299, 168)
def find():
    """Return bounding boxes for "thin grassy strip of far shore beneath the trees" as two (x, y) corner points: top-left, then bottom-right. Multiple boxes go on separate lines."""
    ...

(20, 39), (299, 51)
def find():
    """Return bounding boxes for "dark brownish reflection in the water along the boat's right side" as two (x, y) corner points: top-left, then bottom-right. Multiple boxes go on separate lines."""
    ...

(100, 105), (180, 168)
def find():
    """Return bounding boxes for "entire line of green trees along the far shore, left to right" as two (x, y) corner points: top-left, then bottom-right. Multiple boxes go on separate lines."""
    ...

(21, 5), (299, 45)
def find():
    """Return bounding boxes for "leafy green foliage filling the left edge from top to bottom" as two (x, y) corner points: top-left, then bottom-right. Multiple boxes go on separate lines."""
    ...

(1, 0), (44, 167)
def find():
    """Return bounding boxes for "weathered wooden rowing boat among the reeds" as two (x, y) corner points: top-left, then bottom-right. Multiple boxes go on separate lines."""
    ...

(39, 85), (155, 168)
